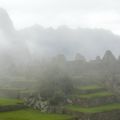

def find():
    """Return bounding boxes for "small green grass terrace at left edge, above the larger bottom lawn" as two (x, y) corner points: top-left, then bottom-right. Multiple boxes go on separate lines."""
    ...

(0, 98), (22, 106)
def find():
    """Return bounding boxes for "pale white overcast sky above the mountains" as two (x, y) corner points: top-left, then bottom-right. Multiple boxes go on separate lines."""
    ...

(0, 0), (120, 34)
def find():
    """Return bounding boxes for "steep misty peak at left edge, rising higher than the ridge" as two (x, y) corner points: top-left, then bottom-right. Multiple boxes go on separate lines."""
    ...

(0, 8), (29, 77)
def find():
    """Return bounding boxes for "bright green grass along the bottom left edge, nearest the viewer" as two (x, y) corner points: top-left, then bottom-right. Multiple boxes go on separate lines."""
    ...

(0, 110), (71, 120)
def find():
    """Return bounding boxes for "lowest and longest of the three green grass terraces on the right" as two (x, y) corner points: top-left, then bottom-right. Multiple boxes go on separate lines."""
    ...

(65, 103), (120, 113)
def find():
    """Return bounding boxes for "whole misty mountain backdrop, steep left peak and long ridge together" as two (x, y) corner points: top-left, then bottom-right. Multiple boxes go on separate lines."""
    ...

(0, 8), (120, 79)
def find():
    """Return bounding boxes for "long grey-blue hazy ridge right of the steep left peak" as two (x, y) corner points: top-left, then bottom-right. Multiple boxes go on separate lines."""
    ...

(19, 25), (120, 58)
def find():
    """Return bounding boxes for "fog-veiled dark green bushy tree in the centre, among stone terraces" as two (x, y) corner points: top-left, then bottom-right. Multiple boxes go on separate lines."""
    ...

(39, 66), (73, 105)
